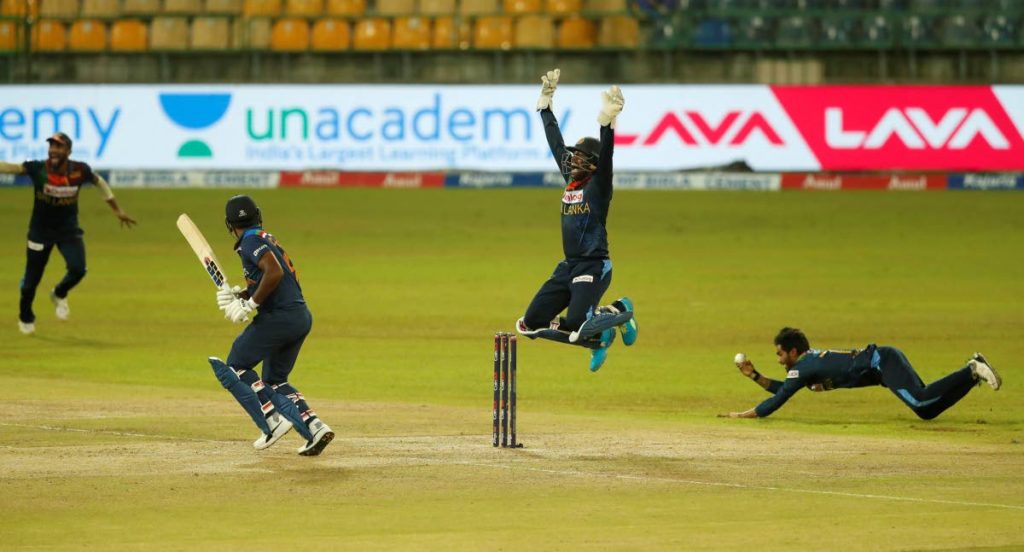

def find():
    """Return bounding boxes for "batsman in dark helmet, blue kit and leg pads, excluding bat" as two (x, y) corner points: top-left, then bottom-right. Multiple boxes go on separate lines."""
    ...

(210, 196), (334, 456)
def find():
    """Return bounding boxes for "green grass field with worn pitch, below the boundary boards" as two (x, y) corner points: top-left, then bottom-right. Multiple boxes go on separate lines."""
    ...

(0, 188), (1024, 550)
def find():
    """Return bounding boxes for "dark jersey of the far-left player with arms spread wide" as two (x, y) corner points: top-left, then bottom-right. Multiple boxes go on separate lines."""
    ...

(22, 161), (95, 242)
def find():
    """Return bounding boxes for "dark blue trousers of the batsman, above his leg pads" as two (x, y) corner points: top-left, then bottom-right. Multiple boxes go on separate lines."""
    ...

(227, 307), (313, 385)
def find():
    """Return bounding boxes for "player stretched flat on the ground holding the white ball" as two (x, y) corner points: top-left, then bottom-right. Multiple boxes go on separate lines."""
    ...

(720, 328), (1002, 420)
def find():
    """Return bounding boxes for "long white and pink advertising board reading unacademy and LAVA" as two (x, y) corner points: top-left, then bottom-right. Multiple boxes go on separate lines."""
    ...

(0, 84), (1024, 172)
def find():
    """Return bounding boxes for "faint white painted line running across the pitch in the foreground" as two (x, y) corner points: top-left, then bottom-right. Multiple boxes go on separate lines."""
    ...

(9, 422), (1024, 510)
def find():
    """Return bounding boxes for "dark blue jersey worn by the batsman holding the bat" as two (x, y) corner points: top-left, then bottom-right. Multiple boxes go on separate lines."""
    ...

(234, 228), (306, 312)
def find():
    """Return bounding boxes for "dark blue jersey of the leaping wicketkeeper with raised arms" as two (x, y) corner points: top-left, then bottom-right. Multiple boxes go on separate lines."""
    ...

(541, 110), (615, 260)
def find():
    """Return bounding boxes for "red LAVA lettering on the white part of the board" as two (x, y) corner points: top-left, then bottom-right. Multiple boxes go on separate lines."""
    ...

(615, 111), (785, 147)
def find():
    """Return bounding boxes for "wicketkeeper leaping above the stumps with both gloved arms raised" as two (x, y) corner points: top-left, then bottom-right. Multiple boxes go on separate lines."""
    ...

(516, 69), (637, 372)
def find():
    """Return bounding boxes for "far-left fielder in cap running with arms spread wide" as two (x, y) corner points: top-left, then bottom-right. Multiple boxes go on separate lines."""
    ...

(0, 132), (135, 335)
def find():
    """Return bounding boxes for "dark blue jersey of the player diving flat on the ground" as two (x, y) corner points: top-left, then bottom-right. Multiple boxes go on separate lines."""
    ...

(754, 345), (882, 418)
